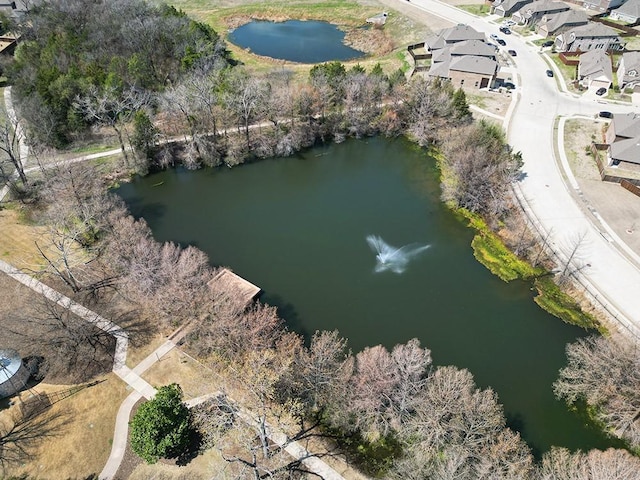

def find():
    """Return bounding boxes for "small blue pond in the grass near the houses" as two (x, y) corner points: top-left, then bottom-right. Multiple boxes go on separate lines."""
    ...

(229, 20), (364, 63)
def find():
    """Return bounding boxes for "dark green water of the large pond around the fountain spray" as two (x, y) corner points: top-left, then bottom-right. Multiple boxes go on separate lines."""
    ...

(118, 138), (612, 453)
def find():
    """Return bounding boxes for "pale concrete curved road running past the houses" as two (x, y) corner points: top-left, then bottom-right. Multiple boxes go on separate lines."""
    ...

(398, 0), (640, 338)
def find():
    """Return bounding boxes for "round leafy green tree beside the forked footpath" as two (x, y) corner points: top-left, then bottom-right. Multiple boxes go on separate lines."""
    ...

(129, 383), (192, 463)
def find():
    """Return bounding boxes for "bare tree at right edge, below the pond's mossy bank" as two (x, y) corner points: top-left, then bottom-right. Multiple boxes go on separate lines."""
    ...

(554, 336), (640, 446)
